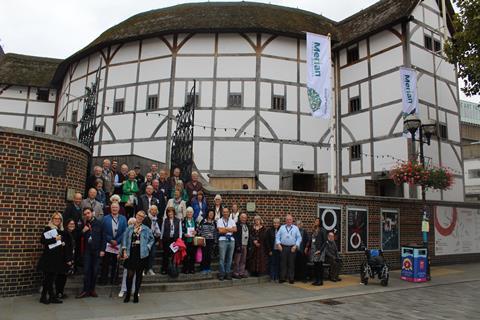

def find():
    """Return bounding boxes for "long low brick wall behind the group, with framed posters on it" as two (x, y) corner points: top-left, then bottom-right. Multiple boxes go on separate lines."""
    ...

(208, 190), (480, 272)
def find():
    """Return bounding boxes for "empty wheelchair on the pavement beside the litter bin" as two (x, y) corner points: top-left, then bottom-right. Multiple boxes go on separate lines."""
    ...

(360, 249), (390, 287)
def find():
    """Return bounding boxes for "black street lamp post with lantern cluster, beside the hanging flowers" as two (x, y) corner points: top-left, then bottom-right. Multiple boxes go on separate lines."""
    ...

(403, 114), (436, 280)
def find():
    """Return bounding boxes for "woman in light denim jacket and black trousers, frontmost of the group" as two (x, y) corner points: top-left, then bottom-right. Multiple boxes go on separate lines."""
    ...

(121, 211), (155, 303)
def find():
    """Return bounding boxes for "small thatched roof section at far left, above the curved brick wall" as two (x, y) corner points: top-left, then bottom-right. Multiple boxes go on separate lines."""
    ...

(0, 53), (62, 88)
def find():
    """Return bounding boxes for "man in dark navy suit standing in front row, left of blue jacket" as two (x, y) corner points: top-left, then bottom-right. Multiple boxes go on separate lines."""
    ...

(76, 208), (105, 298)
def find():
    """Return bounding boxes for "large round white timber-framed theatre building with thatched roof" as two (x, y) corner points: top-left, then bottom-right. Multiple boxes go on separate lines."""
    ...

(0, 0), (464, 201)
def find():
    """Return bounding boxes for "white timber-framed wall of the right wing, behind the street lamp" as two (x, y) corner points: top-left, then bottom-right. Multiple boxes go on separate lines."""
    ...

(338, 0), (464, 201)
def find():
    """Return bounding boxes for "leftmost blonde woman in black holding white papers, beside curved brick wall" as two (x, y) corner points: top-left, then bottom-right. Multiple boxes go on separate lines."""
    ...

(38, 212), (65, 304)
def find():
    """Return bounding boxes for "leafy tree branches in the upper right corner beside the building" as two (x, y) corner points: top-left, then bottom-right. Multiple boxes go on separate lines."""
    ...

(445, 0), (480, 96)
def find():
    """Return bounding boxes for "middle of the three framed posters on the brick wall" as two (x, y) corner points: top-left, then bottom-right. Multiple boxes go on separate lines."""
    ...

(347, 208), (368, 252)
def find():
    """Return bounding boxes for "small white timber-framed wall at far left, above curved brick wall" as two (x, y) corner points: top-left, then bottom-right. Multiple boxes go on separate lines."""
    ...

(0, 84), (57, 134)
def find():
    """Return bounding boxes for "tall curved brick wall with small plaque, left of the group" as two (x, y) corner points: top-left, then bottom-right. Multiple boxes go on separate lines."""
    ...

(0, 127), (88, 296)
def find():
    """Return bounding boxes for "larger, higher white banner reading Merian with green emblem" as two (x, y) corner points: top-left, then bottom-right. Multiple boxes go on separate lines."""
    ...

(307, 33), (332, 119)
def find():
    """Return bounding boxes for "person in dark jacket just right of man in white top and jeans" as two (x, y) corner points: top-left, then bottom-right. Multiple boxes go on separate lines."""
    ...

(232, 213), (251, 279)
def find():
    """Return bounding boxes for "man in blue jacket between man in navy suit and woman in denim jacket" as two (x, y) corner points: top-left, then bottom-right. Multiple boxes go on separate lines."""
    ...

(99, 202), (127, 285)
